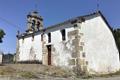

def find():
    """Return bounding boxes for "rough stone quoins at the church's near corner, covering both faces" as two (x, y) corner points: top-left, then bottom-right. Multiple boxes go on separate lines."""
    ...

(68, 29), (87, 75)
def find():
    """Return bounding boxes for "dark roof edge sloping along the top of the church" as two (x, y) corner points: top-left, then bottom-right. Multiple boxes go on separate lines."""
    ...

(17, 11), (111, 38)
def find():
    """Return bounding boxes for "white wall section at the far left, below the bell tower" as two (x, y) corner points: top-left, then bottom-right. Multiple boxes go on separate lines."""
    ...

(19, 35), (42, 61)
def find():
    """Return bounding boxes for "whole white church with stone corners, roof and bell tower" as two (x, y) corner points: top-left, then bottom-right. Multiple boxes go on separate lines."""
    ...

(16, 12), (120, 74)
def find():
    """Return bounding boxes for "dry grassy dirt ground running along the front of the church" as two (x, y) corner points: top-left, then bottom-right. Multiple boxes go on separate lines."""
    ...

(0, 64), (120, 80)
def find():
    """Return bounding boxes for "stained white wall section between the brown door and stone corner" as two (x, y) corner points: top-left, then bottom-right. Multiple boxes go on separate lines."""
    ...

(45, 25), (74, 68)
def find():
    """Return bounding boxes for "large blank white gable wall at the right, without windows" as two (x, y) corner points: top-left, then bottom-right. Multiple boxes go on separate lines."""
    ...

(81, 16), (120, 73)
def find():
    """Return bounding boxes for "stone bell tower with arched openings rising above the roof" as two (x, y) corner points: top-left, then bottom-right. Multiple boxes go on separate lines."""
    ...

(26, 11), (43, 33)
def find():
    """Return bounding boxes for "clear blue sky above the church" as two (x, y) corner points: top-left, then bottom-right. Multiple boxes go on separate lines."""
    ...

(0, 0), (120, 54)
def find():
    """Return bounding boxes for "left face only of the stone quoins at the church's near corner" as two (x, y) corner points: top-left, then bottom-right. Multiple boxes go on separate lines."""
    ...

(68, 30), (80, 74)
